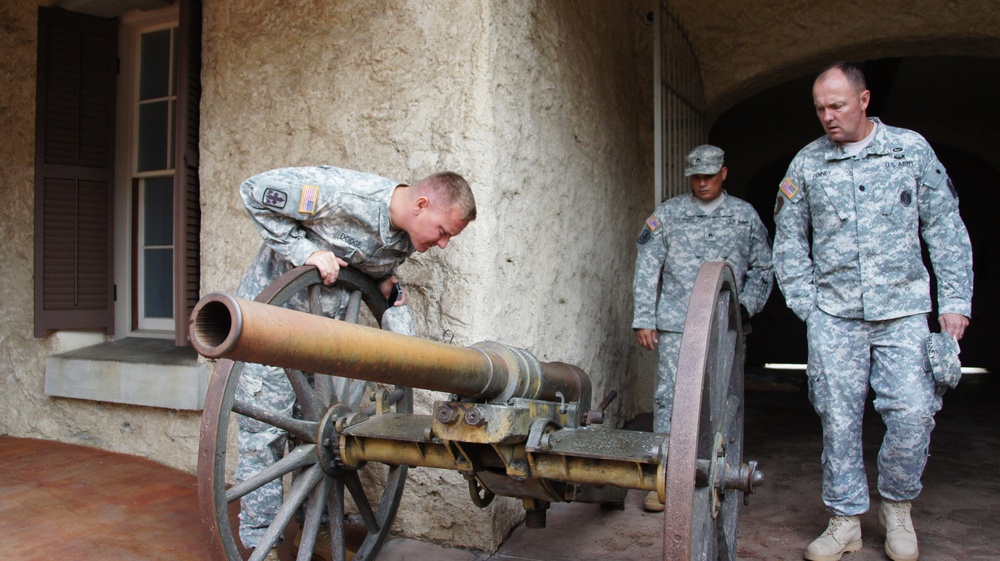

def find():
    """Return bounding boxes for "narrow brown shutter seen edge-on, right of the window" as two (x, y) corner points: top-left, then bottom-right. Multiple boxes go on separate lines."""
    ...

(174, 0), (201, 346)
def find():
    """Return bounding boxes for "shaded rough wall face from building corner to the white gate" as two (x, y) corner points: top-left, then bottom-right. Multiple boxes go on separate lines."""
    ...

(482, 1), (652, 419)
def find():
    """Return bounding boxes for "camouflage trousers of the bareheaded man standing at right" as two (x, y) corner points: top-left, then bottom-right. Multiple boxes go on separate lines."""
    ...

(806, 308), (941, 516)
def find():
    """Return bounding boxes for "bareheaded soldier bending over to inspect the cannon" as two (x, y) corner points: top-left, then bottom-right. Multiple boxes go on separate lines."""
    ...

(236, 166), (476, 560)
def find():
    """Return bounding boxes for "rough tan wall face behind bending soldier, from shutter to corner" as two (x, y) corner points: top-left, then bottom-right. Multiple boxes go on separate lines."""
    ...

(201, 1), (520, 549)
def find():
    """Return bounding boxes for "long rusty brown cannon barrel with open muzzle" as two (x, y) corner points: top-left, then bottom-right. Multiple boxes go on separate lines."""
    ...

(189, 292), (591, 406)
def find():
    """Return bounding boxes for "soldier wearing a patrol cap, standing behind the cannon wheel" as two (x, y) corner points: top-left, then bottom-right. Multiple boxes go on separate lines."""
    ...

(632, 144), (773, 512)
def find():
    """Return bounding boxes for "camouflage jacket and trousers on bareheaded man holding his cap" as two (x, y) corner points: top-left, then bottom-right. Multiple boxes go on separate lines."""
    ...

(774, 118), (972, 516)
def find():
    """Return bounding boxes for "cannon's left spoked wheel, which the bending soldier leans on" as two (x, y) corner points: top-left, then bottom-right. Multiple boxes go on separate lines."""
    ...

(198, 267), (413, 561)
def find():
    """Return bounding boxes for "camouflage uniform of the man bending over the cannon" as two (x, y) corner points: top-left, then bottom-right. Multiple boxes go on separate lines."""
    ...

(236, 166), (414, 547)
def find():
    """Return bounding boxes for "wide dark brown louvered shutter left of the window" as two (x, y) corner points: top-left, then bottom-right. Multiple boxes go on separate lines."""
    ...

(35, 7), (118, 337)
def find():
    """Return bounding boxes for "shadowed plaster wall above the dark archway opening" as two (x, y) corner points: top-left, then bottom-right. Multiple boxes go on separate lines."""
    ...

(669, 0), (1000, 121)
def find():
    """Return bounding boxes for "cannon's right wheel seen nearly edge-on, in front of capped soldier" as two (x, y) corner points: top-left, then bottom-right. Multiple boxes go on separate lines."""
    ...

(663, 262), (763, 561)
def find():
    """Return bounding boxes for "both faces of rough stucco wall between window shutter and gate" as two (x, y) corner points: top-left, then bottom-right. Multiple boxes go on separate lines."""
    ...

(201, 0), (652, 549)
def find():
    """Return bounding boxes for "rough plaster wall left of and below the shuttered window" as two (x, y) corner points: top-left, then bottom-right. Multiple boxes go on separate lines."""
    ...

(0, 0), (200, 472)
